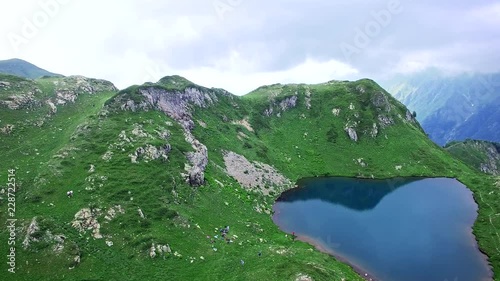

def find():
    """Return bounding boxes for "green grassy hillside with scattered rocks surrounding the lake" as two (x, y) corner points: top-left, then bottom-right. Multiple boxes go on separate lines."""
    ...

(0, 76), (500, 280)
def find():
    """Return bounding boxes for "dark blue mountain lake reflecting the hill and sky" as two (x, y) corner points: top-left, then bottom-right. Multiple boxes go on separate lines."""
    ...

(273, 178), (491, 281)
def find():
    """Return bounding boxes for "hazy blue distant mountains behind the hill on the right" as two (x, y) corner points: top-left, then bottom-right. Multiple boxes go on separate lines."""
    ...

(382, 70), (500, 145)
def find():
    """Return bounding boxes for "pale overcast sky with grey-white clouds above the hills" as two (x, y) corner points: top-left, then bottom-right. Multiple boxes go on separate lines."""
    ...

(0, 0), (500, 95)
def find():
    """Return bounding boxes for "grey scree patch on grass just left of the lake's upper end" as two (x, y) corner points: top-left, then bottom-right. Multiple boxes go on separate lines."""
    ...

(223, 151), (291, 195)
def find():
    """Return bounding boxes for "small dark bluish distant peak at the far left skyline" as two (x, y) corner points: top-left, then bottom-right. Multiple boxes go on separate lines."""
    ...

(0, 59), (63, 79)
